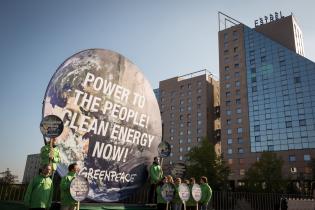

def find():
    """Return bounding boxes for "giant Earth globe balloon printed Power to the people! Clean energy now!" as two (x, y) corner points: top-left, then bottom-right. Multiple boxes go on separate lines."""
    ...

(42, 49), (162, 202)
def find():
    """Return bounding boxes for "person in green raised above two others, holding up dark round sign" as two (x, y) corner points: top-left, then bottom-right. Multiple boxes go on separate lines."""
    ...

(40, 138), (60, 173)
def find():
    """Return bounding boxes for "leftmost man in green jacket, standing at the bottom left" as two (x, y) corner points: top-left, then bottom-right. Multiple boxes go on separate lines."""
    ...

(24, 164), (53, 209)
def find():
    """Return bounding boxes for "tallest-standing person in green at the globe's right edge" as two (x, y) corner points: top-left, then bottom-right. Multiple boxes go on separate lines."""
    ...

(149, 157), (163, 203)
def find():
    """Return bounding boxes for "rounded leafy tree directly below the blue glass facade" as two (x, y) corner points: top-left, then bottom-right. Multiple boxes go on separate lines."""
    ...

(244, 152), (287, 192)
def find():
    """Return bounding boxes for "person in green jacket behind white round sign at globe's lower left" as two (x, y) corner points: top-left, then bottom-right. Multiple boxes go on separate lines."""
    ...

(60, 163), (80, 210)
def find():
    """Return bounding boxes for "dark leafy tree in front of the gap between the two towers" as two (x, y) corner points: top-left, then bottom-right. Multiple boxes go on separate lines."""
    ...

(186, 138), (230, 190)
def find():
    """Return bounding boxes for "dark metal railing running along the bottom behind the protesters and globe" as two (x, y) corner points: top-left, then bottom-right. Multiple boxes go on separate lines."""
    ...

(0, 184), (311, 210)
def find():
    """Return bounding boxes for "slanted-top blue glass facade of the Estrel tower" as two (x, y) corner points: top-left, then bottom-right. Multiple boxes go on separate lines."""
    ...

(244, 26), (315, 152)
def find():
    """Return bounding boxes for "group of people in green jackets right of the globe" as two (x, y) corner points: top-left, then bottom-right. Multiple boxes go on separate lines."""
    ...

(149, 157), (212, 210)
